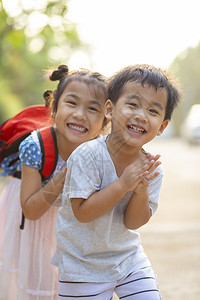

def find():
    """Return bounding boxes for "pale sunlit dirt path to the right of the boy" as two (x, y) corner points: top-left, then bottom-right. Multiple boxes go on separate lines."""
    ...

(115, 139), (200, 300)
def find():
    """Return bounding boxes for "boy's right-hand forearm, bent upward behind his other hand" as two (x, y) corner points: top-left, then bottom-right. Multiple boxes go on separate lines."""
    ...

(124, 171), (160, 230)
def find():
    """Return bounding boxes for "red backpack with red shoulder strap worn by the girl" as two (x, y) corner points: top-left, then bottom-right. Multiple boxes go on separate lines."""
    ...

(0, 105), (58, 179)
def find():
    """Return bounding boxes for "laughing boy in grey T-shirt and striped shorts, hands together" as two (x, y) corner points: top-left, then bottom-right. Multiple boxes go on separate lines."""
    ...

(52, 65), (180, 300)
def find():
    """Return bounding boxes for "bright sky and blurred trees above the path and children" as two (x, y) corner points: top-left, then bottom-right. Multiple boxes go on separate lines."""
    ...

(0, 0), (200, 135)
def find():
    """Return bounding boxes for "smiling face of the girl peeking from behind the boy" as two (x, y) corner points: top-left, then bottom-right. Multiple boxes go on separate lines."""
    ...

(55, 80), (106, 151)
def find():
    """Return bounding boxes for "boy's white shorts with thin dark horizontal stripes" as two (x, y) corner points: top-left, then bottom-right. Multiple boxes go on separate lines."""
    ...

(59, 259), (161, 300)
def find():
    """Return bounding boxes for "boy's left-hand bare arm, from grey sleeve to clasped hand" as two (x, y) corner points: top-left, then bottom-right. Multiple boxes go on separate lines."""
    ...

(71, 156), (159, 223)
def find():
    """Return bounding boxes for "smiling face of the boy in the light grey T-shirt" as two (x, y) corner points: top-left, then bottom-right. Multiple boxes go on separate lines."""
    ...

(106, 82), (168, 147)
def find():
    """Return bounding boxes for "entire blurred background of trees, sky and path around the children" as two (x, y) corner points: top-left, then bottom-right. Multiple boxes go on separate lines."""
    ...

(0, 0), (200, 300)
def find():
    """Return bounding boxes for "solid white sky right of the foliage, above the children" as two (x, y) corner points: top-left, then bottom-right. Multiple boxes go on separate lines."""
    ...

(69, 0), (200, 75)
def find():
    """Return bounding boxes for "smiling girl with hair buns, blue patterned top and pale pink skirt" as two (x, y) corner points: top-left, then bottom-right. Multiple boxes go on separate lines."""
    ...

(0, 65), (107, 300)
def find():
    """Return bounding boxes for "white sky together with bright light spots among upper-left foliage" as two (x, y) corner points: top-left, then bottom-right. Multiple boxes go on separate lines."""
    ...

(3, 0), (200, 76)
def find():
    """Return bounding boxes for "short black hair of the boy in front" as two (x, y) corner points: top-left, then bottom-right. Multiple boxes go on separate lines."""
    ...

(108, 64), (181, 121)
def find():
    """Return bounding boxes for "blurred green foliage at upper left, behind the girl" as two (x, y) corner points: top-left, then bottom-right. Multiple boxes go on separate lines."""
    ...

(0, 0), (82, 124)
